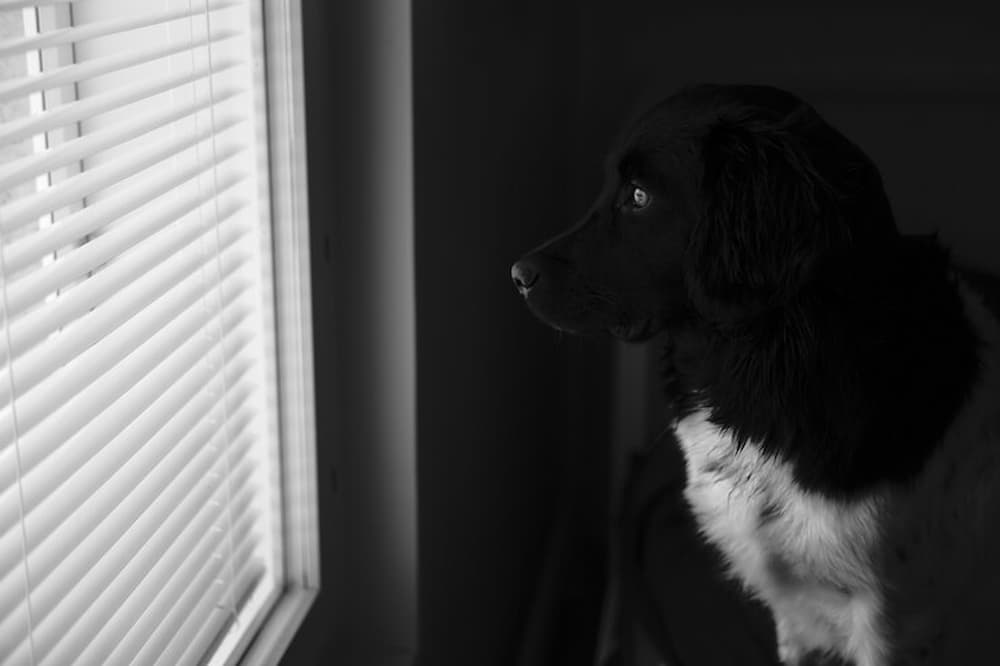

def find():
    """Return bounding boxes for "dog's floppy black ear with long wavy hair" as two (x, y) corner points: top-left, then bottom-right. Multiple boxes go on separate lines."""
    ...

(685, 109), (850, 322)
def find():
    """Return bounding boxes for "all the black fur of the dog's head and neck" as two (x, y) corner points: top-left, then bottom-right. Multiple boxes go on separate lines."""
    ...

(515, 85), (977, 496)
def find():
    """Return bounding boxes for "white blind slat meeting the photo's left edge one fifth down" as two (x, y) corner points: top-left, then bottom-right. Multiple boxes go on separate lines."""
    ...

(0, 58), (246, 144)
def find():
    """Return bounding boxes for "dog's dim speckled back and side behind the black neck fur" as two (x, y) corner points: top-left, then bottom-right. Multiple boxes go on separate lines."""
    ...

(880, 282), (1000, 665)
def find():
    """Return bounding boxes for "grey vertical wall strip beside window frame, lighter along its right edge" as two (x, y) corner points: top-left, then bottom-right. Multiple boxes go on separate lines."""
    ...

(283, 0), (418, 666)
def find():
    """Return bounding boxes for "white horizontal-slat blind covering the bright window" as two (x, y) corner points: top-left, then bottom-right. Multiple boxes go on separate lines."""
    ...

(0, 0), (283, 666)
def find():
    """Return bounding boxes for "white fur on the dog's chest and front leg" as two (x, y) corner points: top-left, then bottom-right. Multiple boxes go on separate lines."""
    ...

(675, 411), (886, 666)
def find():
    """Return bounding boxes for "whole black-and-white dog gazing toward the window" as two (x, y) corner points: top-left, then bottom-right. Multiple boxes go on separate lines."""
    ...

(511, 85), (1000, 666)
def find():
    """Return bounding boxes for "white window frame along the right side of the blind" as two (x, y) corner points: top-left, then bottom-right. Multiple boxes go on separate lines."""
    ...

(226, 0), (320, 666)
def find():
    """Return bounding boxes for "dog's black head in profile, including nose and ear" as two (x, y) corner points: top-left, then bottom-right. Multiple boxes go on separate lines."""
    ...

(511, 85), (897, 340)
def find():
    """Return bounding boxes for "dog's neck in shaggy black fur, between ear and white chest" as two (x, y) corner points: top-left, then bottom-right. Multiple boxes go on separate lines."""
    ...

(663, 236), (978, 497)
